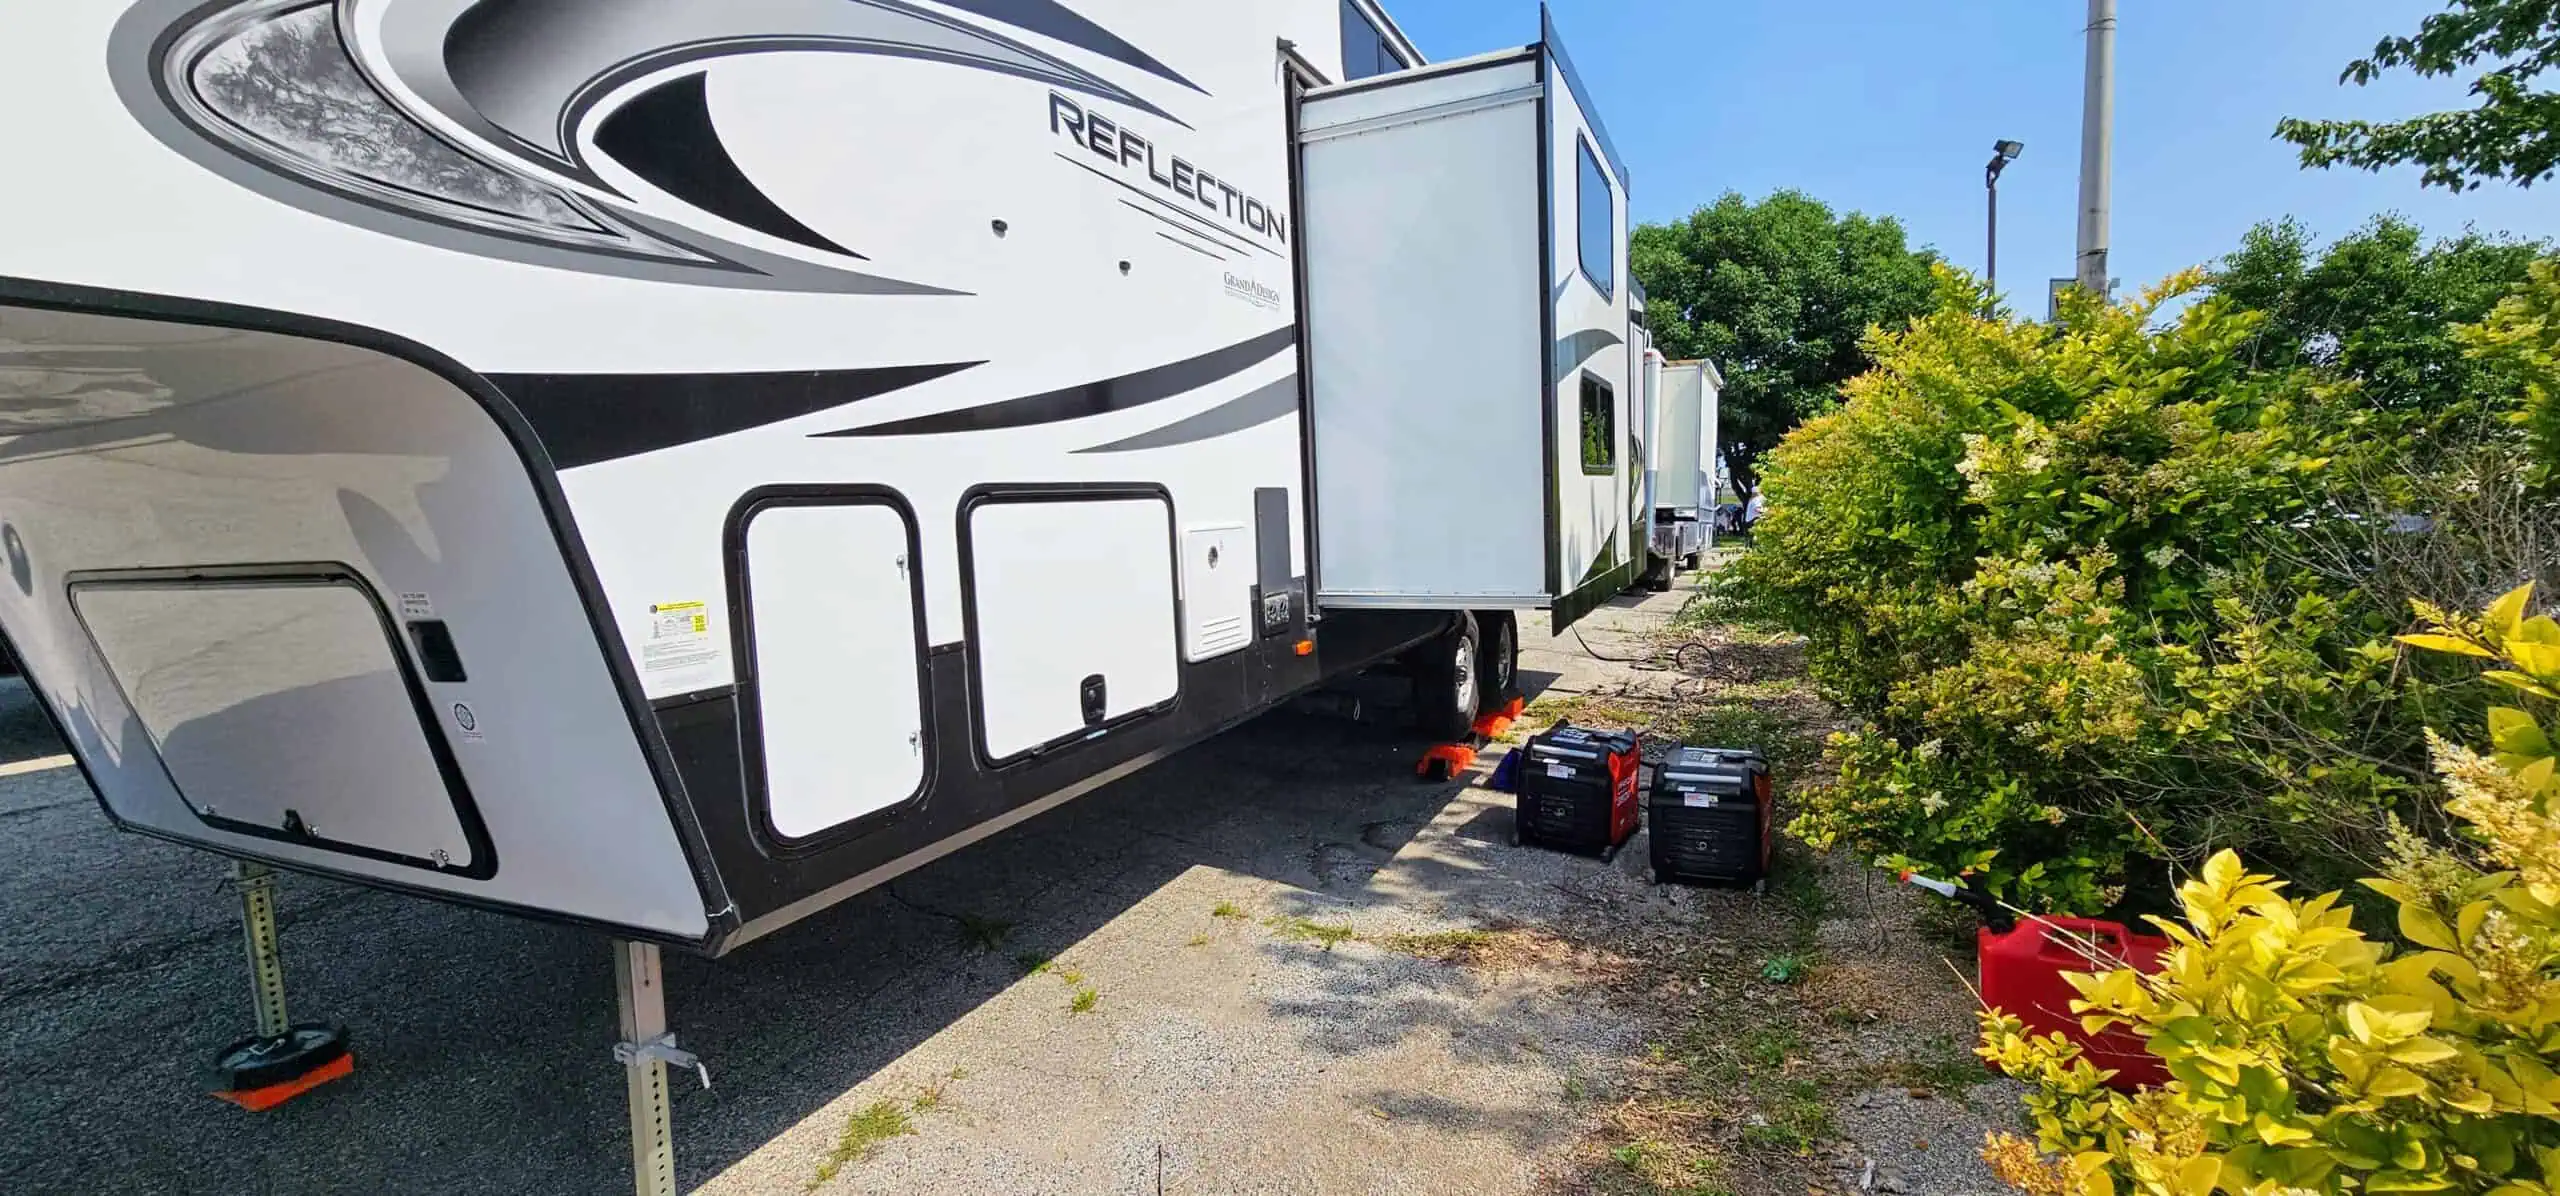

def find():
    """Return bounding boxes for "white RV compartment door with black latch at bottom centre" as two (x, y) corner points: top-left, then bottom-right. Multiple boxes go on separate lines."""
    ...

(965, 492), (1177, 766)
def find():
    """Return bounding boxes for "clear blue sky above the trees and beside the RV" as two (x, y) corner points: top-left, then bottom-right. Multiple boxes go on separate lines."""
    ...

(1385, 0), (2560, 312)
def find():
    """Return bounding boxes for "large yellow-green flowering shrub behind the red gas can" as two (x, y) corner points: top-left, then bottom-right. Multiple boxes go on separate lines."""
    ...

(1718, 266), (2560, 912)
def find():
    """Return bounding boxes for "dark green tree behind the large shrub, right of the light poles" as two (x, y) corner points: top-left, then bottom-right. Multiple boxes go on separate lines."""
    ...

(2214, 215), (2550, 410)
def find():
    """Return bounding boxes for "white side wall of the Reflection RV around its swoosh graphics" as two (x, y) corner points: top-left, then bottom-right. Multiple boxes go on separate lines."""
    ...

(0, 0), (1341, 697)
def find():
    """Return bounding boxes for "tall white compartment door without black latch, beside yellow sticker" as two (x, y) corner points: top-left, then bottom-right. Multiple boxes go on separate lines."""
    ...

(740, 502), (924, 843)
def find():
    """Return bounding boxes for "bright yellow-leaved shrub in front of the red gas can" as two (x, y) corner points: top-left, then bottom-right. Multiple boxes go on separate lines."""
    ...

(1981, 586), (2560, 1196)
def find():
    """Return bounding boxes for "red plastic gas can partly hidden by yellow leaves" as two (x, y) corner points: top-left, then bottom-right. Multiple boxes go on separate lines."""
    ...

(1974, 917), (2168, 1091)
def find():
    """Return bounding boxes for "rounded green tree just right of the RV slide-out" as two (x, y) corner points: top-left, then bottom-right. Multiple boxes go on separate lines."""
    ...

(1631, 190), (1935, 479)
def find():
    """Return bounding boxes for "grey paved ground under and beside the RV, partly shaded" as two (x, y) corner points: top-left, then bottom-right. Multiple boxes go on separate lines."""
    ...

(0, 594), (2027, 1196)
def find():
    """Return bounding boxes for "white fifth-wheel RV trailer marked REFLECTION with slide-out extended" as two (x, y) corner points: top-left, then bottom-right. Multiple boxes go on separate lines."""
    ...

(0, 0), (1641, 1186)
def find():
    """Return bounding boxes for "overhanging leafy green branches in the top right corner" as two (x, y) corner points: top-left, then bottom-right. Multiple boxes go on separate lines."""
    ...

(2276, 0), (2560, 192)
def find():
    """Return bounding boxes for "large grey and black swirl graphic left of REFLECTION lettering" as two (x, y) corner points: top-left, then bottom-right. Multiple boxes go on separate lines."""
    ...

(110, 0), (1208, 295)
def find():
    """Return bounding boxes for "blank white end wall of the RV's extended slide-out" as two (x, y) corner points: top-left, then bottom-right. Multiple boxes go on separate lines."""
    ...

(1298, 54), (1551, 610)
